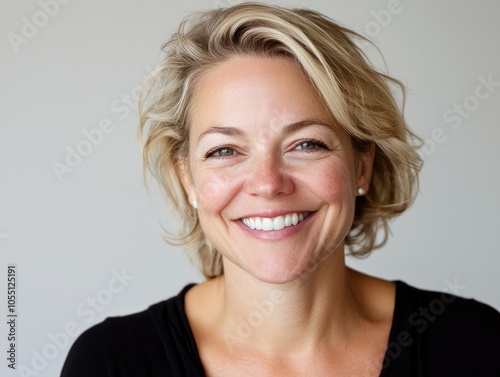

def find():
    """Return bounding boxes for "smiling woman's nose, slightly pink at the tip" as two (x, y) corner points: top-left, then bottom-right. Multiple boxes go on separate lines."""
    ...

(246, 155), (295, 199)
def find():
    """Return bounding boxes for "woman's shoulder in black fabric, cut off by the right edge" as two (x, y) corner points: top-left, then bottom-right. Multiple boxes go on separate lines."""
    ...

(386, 282), (500, 376)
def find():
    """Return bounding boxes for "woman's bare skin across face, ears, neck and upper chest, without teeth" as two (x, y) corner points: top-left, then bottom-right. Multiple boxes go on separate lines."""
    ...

(180, 56), (394, 376)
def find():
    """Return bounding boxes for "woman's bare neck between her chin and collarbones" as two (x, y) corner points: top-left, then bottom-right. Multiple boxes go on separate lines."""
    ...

(216, 250), (357, 355)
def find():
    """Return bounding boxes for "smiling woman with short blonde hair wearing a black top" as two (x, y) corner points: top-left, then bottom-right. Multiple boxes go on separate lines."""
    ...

(62, 3), (500, 376)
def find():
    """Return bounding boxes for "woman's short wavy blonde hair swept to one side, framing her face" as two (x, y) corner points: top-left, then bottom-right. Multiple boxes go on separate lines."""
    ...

(139, 3), (422, 278)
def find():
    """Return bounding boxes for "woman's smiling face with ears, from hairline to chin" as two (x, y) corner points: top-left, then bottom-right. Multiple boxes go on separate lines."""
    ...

(182, 57), (371, 283)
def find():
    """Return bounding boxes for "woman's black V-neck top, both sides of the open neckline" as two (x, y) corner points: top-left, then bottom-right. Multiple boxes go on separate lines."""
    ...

(61, 281), (500, 377)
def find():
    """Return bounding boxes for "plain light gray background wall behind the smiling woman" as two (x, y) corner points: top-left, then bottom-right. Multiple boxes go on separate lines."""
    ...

(0, 0), (500, 376)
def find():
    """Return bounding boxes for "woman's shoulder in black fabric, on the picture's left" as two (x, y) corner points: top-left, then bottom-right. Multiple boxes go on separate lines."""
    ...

(61, 285), (202, 377)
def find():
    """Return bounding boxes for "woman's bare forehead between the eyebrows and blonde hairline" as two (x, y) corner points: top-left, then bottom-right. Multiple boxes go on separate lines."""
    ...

(191, 56), (332, 137)
